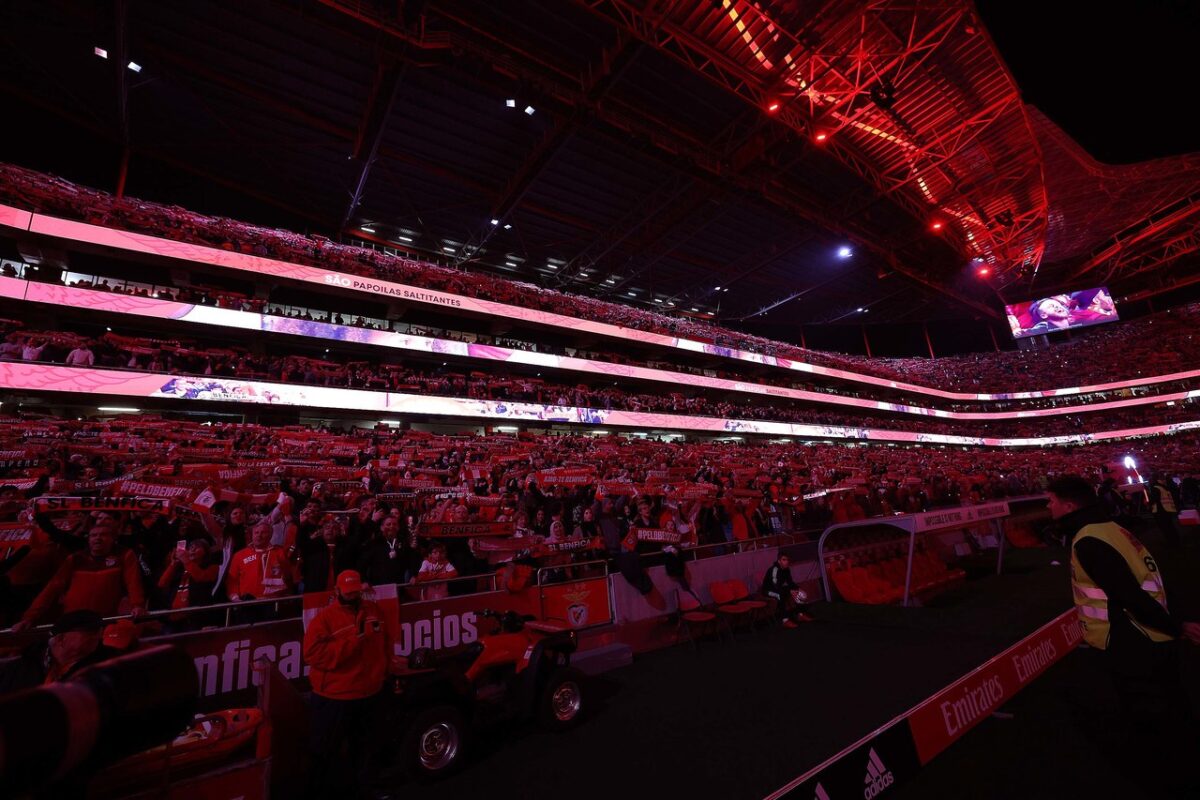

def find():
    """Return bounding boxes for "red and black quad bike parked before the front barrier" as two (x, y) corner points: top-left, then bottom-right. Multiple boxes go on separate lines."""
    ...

(392, 610), (584, 780)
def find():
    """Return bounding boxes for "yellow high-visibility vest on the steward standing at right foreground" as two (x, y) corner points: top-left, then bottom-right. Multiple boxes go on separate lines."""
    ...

(1070, 522), (1175, 650)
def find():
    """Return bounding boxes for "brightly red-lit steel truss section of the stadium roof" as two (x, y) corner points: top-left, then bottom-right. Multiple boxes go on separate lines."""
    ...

(577, 0), (1049, 286)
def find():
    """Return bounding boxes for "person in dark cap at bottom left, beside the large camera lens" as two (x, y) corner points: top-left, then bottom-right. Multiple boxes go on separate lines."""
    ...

(0, 609), (119, 696)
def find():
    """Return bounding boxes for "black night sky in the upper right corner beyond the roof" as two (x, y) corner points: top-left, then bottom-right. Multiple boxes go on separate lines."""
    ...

(976, 0), (1200, 164)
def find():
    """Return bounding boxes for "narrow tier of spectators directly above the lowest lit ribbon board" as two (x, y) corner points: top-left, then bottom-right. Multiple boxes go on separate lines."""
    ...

(0, 323), (1196, 438)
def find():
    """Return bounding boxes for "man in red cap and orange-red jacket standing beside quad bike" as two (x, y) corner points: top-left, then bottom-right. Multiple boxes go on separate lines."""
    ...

(304, 570), (398, 798)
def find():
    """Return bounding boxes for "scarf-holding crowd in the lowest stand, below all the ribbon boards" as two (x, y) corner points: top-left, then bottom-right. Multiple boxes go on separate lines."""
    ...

(0, 416), (1200, 627)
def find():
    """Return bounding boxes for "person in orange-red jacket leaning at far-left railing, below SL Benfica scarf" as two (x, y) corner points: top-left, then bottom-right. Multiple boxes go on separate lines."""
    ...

(13, 524), (145, 631)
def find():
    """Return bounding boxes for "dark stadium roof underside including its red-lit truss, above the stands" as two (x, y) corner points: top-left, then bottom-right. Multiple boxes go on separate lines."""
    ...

(0, 0), (1183, 324)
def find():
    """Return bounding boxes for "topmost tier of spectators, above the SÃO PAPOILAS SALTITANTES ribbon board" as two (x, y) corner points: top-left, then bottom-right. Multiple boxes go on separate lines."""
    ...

(7, 164), (1198, 392)
